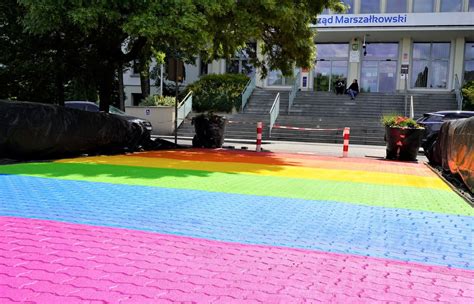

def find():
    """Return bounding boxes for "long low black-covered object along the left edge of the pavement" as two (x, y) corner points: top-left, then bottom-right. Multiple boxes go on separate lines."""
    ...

(0, 101), (150, 159)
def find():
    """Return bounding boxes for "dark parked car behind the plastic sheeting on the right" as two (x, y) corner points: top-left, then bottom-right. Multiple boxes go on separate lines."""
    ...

(416, 111), (474, 151)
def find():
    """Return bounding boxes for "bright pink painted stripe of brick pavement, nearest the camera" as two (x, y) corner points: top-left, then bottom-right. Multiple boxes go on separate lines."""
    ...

(0, 217), (474, 303)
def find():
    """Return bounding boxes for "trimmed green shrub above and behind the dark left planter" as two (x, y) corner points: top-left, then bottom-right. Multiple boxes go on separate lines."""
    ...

(184, 74), (249, 113)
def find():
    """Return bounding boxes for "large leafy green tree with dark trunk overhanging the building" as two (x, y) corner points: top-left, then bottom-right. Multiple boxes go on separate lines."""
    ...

(18, 0), (344, 111)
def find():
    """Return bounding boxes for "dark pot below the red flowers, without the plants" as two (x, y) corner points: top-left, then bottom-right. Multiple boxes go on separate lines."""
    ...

(385, 127), (424, 161)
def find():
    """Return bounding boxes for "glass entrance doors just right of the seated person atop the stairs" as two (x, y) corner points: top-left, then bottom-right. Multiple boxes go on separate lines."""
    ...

(360, 60), (397, 92)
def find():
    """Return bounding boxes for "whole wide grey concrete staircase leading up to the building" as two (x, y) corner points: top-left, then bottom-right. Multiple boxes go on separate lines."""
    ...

(178, 89), (456, 145)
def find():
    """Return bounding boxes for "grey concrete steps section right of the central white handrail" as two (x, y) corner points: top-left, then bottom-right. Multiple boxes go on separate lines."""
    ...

(272, 92), (456, 145)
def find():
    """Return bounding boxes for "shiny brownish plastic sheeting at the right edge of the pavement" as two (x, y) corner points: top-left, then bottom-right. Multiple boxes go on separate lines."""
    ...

(436, 117), (474, 192)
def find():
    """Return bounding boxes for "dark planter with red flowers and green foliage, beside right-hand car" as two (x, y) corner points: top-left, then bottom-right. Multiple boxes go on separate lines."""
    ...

(382, 115), (424, 161)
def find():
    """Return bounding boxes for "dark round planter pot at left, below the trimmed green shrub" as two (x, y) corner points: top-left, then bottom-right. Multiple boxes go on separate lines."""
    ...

(192, 114), (227, 148)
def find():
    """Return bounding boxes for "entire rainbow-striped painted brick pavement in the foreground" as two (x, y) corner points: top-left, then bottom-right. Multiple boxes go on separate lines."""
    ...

(0, 150), (474, 303)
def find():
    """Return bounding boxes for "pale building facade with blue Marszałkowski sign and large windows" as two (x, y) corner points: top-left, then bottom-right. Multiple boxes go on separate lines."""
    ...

(124, 0), (474, 104)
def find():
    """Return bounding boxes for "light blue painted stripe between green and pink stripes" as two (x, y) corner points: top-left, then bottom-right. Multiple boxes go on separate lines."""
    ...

(0, 175), (474, 269)
